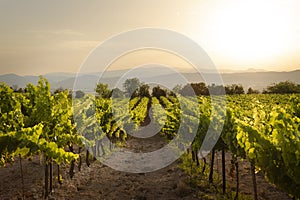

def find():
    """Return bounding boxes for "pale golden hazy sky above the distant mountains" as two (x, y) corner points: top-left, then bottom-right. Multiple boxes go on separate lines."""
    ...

(0, 0), (300, 75)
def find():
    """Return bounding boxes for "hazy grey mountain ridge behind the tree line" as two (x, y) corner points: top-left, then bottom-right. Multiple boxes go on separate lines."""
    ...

(0, 69), (300, 91)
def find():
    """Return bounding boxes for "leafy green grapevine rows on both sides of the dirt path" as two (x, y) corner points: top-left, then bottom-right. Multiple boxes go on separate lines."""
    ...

(0, 78), (300, 199)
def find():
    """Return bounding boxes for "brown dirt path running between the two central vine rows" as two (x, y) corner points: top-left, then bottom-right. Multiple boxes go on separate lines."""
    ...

(50, 136), (197, 200)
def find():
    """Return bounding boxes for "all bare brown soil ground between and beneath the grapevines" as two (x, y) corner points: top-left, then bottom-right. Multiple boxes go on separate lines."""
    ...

(0, 135), (290, 200)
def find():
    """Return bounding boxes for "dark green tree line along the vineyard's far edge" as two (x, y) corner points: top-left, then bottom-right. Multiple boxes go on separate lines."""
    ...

(11, 78), (300, 98)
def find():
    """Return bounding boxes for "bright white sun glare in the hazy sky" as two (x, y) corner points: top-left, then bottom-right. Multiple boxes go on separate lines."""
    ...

(211, 1), (291, 62)
